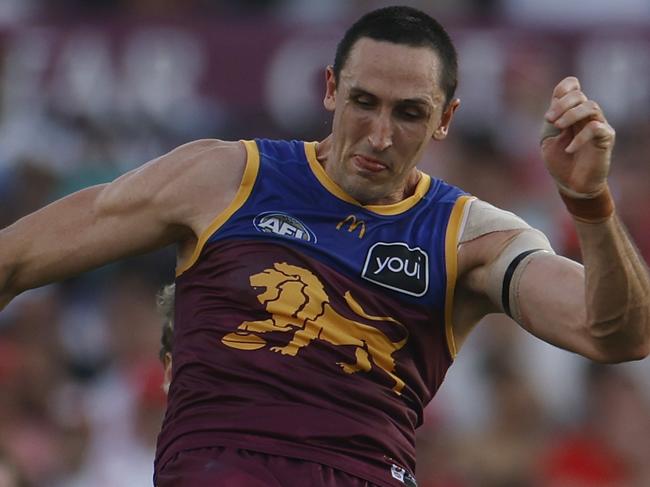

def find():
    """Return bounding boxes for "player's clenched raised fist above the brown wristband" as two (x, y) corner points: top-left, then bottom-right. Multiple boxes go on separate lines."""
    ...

(541, 76), (615, 195)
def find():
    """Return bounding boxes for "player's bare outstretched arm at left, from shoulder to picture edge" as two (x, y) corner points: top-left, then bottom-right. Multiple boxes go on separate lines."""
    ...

(0, 140), (246, 309)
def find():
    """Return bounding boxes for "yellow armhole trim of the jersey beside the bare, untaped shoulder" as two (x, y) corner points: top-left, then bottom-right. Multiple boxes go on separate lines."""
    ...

(176, 140), (260, 277)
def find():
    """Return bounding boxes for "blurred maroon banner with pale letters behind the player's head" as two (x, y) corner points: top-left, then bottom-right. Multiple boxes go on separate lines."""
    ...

(0, 19), (650, 173)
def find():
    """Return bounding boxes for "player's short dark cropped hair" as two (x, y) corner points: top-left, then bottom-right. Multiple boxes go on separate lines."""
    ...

(333, 7), (458, 107)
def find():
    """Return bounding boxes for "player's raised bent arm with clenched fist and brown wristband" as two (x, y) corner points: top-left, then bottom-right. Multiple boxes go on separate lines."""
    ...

(459, 77), (650, 362)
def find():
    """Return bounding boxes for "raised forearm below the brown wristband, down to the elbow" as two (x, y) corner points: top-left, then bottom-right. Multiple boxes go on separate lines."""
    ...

(575, 214), (650, 361)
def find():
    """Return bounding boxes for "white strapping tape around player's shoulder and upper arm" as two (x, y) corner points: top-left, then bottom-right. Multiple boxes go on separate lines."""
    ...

(460, 200), (555, 321)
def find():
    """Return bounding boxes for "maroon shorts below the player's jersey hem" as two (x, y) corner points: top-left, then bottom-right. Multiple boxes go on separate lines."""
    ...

(156, 447), (376, 487)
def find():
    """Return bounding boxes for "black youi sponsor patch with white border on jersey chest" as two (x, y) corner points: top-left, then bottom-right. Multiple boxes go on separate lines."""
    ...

(361, 242), (429, 296)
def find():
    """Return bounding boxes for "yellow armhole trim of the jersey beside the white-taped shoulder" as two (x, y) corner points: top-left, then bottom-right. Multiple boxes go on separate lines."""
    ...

(445, 195), (476, 360)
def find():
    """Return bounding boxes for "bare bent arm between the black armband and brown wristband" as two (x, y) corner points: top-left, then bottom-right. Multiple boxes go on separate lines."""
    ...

(510, 215), (650, 363)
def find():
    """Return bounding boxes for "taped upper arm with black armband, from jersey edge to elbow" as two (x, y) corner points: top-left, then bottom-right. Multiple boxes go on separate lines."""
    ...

(454, 198), (612, 358)
